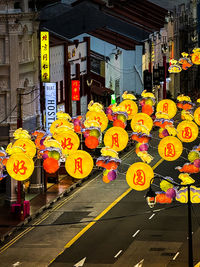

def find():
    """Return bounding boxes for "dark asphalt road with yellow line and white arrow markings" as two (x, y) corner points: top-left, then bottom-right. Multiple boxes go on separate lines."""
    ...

(0, 131), (200, 267)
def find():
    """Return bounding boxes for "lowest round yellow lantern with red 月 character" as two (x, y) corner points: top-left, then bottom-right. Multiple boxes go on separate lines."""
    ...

(65, 150), (94, 179)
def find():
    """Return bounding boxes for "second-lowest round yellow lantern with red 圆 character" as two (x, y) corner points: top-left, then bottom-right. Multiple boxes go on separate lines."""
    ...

(158, 136), (183, 161)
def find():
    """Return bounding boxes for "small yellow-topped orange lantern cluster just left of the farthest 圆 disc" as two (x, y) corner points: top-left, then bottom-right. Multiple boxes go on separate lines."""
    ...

(140, 90), (155, 116)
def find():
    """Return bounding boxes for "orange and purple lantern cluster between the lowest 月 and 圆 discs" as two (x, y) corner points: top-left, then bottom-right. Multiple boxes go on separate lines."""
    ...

(96, 147), (121, 183)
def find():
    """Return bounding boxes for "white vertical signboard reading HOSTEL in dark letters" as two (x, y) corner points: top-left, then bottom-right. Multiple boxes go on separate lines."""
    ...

(45, 83), (56, 132)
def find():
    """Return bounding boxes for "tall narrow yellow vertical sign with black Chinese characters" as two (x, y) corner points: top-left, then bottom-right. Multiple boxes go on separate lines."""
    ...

(40, 32), (50, 82)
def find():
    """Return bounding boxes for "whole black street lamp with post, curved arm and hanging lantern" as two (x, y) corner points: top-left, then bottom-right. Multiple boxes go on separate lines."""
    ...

(146, 176), (193, 267)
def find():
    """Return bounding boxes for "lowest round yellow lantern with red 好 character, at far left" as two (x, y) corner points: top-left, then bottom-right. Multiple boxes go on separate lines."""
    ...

(6, 153), (34, 181)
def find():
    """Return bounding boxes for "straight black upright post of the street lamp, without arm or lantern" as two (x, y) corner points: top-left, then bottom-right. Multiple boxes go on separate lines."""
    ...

(187, 185), (193, 267)
